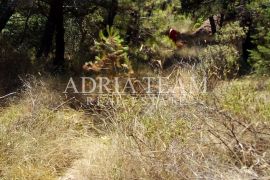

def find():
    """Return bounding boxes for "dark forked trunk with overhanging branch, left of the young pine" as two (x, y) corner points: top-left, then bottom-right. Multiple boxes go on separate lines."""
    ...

(37, 0), (118, 67)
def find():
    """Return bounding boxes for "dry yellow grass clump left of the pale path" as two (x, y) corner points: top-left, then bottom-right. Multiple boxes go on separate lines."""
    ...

(0, 76), (92, 179)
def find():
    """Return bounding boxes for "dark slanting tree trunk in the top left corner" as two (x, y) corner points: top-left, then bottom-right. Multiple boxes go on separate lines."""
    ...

(0, 0), (18, 32)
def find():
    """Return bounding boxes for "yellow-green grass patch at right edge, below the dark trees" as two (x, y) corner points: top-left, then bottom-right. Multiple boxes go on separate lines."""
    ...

(218, 78), (270, 122)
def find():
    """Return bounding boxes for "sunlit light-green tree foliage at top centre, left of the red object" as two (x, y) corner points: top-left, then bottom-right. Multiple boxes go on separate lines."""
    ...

(115, 0), (194, 62)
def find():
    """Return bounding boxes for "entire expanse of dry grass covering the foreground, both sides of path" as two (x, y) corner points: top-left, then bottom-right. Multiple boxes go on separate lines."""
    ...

(0, 71), (270, 180)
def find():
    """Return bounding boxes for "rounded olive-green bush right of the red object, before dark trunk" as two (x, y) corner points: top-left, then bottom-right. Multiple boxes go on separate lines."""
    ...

(199, 21), (246, 83)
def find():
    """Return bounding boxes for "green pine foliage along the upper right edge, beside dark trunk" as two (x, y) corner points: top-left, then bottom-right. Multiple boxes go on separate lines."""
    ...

(250, 0), (270, 75)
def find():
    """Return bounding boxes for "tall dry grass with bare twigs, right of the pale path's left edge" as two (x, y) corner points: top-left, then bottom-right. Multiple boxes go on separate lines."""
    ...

(61, 72), (270, 179)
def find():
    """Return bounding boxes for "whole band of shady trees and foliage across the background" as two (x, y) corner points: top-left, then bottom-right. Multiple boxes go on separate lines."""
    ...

(0, 0), (269, 74)
